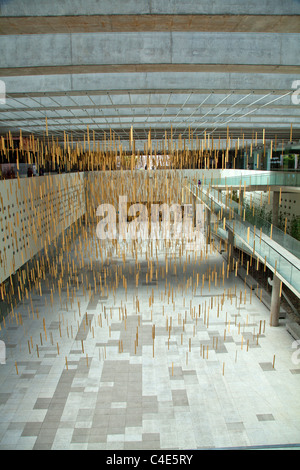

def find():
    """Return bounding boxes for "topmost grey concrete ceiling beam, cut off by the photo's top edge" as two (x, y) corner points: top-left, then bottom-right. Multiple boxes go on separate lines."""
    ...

(0, 0), (300, 17)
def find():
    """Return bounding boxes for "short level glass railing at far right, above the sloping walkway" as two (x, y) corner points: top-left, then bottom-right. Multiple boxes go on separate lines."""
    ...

(202, 172), (300, 189)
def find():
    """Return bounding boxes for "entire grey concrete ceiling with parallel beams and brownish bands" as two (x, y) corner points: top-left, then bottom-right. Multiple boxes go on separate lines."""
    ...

(0, 0), (300, 145)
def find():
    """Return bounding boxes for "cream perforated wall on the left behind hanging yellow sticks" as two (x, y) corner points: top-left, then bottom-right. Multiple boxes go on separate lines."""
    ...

(0, 173), (85, 283)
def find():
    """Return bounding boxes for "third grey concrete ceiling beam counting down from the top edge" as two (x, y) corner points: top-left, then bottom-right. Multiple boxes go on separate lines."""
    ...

(0, 72), (299, 96)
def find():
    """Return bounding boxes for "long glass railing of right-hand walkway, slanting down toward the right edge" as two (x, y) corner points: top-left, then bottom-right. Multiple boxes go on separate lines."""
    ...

(190, 183), (300, 292)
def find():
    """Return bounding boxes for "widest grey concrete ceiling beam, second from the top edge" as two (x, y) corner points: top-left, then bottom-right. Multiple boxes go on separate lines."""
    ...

(0, 33), (300, 76)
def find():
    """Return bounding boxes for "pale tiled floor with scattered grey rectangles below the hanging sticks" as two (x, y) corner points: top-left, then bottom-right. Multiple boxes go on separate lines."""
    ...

(0, 233), (300, 450)
